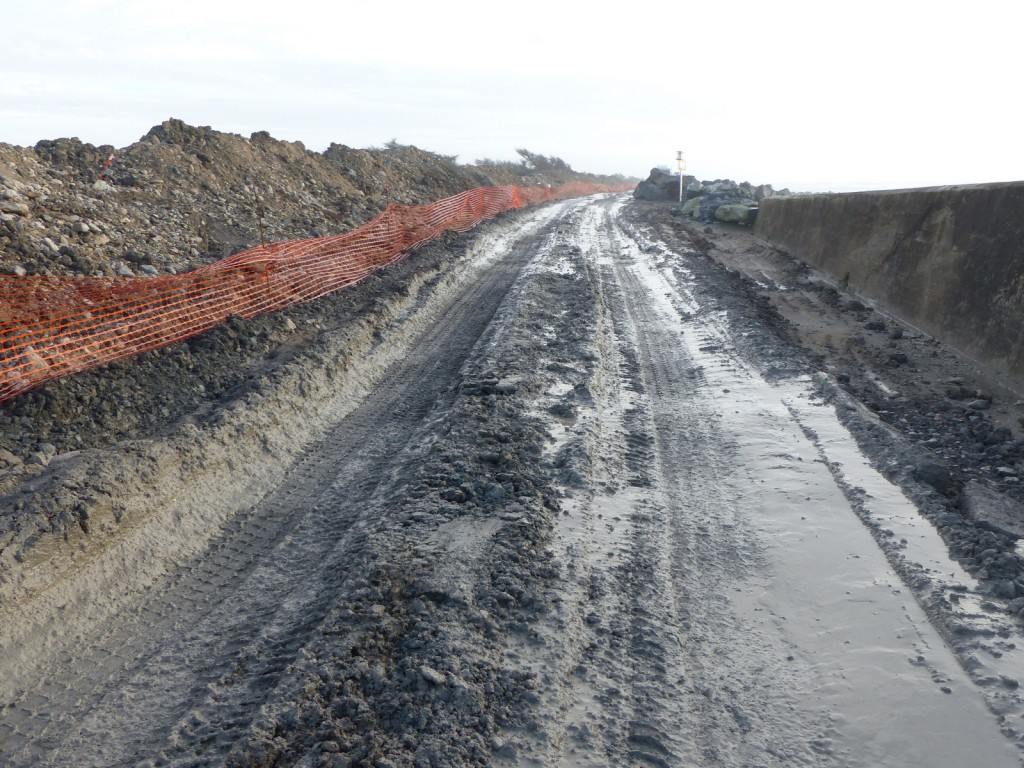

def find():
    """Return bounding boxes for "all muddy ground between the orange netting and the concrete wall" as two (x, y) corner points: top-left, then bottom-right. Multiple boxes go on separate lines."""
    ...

(0, 196), (1024, 767)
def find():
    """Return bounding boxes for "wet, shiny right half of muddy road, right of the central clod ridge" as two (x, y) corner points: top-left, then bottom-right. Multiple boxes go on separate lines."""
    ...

(505, 203), (1024, 768)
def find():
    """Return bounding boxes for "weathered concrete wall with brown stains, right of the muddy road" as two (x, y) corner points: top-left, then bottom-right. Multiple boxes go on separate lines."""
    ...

(754, 181), (1024, 382)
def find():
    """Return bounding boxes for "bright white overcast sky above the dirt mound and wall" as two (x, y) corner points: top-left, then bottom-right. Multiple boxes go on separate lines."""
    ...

(0, 0), (1024, 191)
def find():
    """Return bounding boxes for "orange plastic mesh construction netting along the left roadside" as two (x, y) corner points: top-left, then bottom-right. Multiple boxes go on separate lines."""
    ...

(0, 182), (621, 401)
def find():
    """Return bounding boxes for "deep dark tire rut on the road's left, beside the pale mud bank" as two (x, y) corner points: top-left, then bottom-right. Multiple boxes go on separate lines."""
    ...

(0, 201), (581, 766)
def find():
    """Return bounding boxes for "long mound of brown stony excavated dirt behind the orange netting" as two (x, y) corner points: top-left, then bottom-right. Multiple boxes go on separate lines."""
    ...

(0, 120), (623, 275)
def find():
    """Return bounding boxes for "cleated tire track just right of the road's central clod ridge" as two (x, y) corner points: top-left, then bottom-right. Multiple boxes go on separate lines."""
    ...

(561, 199), (790, 766)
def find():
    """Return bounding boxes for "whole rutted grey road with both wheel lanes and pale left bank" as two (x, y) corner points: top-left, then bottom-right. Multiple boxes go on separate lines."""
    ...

(0, 197), (1024, 768)
